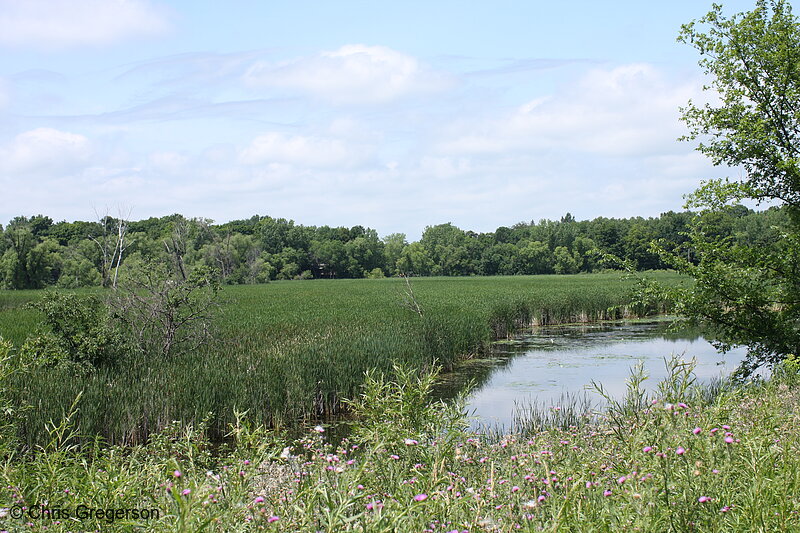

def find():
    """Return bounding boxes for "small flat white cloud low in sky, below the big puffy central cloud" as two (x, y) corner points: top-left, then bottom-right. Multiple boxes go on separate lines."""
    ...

(239, 132), (369, 167)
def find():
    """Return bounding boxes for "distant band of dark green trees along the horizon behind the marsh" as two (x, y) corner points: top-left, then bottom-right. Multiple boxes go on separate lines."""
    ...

(0, 205), (787, 289)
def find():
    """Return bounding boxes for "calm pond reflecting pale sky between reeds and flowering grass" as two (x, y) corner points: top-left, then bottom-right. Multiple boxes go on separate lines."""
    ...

(438, 320), (745, 428)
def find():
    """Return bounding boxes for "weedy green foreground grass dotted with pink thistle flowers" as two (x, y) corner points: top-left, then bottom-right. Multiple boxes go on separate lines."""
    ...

(0, 352), (800, 533)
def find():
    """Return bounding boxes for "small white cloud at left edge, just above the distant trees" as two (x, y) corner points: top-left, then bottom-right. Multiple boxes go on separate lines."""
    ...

(0, 128), (92, 174)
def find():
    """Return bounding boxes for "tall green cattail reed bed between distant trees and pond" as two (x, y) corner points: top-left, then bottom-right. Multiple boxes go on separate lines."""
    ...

(0, 273), (678, 445)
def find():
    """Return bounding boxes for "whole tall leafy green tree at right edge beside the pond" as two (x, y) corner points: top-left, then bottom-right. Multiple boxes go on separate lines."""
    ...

(665, 0), (800, 373)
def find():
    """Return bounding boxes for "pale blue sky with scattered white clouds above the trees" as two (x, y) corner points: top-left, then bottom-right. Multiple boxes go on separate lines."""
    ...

(0, 0), (772, 240)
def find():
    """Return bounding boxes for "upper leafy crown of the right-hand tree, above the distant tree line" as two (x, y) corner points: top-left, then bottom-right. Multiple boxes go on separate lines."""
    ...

(678, 0), (800, 205)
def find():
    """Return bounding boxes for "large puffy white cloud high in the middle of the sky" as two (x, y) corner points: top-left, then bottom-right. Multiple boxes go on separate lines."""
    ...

(244, 44), (453, 104)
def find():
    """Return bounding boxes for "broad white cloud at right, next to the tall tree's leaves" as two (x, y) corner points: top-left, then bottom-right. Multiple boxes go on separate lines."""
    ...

(438, 64), (701, 156)
